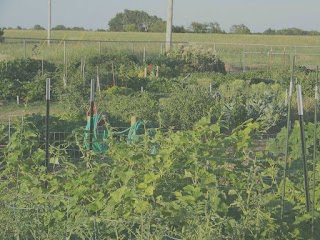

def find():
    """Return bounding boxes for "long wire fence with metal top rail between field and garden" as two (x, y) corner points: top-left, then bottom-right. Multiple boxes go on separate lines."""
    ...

(0, 38), (320, 72)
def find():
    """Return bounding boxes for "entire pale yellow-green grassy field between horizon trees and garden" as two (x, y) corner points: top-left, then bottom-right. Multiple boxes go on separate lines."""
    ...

(0, 30), (320, 71)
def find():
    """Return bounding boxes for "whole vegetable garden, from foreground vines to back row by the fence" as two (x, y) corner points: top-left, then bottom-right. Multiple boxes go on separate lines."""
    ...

(0, 42), (320, 239)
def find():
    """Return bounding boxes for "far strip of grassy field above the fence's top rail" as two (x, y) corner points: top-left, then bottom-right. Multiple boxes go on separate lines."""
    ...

(4, 30), (320, 46)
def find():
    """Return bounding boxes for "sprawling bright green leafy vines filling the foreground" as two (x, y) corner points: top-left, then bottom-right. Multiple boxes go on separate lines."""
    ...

(0, 116), (320, 239)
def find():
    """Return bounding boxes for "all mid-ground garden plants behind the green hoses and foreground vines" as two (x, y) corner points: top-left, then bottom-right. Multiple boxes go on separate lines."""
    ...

(0, 48), (315, 133)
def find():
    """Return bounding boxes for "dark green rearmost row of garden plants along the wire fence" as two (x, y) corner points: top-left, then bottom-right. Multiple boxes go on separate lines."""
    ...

(0, 46), (225, 101)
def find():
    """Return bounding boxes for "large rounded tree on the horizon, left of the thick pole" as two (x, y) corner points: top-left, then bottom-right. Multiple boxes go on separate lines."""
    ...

(108, 9), (164, 32)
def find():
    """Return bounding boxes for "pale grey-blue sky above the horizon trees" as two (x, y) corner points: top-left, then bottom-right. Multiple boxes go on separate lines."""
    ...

(0, 0), (320, 32)
